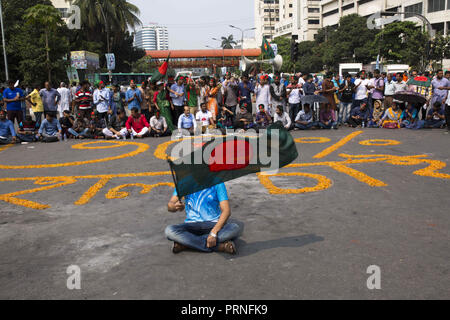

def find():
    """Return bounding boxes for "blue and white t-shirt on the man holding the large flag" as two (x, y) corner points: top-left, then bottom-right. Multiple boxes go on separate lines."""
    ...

(173, 183), (228, 223)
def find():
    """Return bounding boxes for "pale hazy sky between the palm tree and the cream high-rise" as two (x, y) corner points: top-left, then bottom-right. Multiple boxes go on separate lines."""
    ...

(128, 0), (254, 50)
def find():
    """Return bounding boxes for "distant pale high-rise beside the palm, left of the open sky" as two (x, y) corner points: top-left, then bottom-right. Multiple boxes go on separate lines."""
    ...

(134, 23), (169, 50)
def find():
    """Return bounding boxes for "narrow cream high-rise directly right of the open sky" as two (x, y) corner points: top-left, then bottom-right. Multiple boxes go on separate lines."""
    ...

(255, 0), (281, 43)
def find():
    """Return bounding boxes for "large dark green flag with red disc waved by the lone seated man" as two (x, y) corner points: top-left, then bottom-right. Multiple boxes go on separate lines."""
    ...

(168, 123), (298, 199)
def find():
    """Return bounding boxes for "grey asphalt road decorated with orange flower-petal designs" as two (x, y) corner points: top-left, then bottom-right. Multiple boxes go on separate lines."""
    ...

(0, 128), (450, 299)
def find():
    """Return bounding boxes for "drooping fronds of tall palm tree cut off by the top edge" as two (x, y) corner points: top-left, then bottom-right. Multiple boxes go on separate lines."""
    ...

(74, 0), (142, 34)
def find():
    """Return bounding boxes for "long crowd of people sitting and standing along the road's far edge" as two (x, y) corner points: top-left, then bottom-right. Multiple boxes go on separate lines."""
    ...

(0, 70), (450, 144)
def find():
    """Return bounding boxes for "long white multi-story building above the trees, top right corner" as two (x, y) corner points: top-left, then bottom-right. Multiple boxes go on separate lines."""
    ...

(321, 0), (450, 34)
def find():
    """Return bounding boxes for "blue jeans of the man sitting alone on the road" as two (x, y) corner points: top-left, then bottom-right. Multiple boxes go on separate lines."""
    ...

(165, 221), (240, 252)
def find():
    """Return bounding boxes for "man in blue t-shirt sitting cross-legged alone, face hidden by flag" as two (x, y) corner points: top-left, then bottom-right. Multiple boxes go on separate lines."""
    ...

(165, 183), (240, 254)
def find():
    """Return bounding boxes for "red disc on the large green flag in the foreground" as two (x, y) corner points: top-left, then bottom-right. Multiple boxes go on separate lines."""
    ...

(209, 140), (253, 172)
